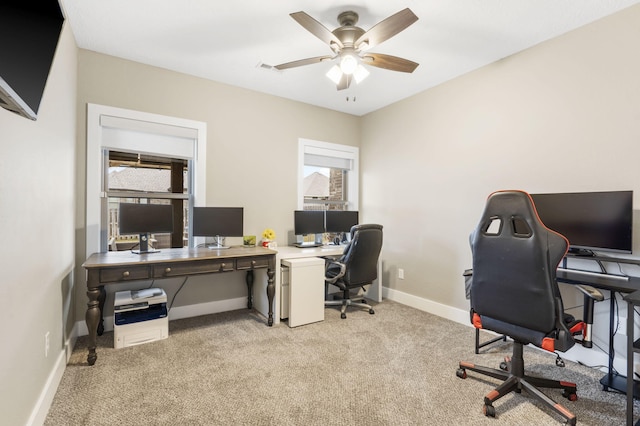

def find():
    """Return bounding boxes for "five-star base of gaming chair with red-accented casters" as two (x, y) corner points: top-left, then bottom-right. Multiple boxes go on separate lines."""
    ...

(456, 342), (578, 425)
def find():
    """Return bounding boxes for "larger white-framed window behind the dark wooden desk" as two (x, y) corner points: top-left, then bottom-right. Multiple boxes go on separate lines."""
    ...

(86, 104), (207, 256)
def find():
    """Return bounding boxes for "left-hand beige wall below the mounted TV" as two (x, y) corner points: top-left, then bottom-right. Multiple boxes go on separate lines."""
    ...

(0, 25), (77, 425)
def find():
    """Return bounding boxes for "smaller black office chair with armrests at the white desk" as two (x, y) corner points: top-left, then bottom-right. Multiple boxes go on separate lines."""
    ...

(324, 224), (382, 319)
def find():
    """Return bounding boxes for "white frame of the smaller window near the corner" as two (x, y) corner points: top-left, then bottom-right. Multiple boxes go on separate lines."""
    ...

(298, 139), (360, 210)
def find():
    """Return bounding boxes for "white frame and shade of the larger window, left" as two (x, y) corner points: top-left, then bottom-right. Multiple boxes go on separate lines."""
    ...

(85, 104), (207, 257)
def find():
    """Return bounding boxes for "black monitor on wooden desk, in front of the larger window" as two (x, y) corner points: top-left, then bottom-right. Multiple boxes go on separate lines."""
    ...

(118, 203), (173, 253)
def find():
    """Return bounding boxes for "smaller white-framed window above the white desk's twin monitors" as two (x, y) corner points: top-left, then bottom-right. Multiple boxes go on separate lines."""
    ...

(298, 139), (358, 210)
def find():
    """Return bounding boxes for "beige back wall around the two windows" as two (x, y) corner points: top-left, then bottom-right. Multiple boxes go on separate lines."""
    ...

(76, 50), (360, 321)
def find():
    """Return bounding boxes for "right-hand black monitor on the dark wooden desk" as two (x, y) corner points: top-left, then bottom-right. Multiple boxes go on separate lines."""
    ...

(192, 207), (244, 249)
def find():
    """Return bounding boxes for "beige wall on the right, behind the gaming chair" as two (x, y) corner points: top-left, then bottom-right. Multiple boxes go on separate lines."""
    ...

(361, 2), (640, 310)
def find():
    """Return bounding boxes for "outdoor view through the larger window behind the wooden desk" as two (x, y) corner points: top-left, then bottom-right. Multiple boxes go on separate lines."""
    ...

(105, 151), (191, 250)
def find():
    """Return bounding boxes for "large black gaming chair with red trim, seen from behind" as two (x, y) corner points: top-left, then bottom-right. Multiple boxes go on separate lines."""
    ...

(457, 191), (596, 425)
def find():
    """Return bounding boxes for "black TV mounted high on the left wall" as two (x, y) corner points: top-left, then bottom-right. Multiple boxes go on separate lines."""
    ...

(0, 0), (64, 120)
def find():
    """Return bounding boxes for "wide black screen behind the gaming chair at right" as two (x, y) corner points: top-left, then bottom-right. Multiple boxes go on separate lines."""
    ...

(531, 191), (633, 253)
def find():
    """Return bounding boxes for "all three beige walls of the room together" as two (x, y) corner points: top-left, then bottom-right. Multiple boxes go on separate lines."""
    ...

(0, 6), (640, 424)
